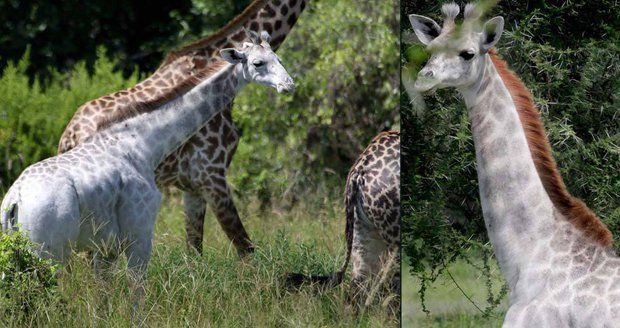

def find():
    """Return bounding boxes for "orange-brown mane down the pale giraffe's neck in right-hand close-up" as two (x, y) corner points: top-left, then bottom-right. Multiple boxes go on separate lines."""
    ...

(489, 50), (613, 247)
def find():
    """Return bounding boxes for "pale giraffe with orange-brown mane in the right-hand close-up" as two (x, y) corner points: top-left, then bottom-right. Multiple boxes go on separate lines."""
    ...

(409, 3), (620, 327)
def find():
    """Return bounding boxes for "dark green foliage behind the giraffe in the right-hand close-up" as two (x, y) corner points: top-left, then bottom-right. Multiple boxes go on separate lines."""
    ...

(401, 1), (620, 312)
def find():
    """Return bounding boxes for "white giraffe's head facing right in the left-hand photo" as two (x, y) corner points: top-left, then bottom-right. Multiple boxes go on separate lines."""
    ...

(220, 30), (295, 93)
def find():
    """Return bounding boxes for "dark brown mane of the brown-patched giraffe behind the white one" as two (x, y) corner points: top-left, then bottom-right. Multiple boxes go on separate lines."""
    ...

(162, 0), (267, 66)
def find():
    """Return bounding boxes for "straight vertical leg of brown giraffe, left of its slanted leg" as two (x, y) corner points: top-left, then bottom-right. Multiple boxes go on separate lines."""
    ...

(183, 192), (207, 254)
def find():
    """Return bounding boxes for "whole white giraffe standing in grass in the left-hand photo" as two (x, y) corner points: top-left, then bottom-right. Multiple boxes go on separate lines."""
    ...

(0, 31), (294, 308)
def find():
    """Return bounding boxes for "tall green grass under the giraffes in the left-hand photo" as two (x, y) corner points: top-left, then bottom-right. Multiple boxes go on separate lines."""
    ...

(0, 188), (398, 327)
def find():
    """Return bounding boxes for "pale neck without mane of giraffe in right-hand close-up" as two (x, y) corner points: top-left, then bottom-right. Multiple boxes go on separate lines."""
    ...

(459, 55), (558, 291)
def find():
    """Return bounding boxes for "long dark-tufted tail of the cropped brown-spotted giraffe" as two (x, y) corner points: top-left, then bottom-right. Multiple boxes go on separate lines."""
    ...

(286, 171), (366, 287)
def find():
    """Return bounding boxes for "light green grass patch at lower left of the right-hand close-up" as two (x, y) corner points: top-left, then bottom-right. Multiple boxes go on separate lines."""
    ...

(402, 256), (507, 328)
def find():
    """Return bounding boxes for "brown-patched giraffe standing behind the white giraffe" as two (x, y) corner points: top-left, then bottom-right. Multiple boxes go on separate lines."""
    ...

(58, 0), (308, 256)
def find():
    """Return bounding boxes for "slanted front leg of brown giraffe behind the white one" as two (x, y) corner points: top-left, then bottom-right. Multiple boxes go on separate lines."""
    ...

(206, 184), (254, 257)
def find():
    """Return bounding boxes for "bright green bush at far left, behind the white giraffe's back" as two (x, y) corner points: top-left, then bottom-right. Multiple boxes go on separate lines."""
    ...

(0, 49), (138, 194)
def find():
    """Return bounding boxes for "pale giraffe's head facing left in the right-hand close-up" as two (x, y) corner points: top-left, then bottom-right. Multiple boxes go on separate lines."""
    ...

(409, 3), (504, 92)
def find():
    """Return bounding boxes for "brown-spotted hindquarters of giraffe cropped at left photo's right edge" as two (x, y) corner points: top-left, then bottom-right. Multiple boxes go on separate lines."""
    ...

(345, 131), (400, 287)
